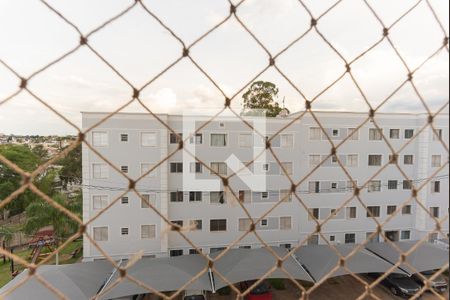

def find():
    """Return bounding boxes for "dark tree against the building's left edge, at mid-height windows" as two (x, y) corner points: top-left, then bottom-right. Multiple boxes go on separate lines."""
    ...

(57, 144), (82, 189)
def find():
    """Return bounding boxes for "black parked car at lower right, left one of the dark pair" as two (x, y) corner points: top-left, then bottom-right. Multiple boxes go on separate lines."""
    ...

(369, 273), (422, 298)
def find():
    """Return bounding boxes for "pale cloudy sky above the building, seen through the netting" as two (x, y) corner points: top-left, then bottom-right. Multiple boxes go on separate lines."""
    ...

(0, 0), (449, 134)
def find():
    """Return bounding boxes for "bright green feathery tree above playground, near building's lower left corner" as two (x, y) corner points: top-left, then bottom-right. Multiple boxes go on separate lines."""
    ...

(24, 193), (82, 239)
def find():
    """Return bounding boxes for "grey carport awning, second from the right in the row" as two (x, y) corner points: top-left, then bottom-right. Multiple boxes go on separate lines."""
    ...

(295, 245), (404, 281)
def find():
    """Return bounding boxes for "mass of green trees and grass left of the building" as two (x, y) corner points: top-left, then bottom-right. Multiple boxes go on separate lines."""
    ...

(0, 144), (82, 286)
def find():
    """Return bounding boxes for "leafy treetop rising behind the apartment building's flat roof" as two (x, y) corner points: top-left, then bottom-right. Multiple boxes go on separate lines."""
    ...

(242, 81), (282, 117)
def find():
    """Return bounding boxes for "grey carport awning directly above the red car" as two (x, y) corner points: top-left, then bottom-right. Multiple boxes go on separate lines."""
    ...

(214, 247), (313, 289)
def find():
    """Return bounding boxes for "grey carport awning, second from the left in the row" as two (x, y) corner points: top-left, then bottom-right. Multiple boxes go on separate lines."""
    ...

(101, 255), (211, 299)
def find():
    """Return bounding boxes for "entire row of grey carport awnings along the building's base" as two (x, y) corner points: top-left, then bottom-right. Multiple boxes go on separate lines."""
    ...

(0, 241), (448, 299)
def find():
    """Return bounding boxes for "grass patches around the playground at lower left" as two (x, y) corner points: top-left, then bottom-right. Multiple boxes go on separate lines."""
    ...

(0, 240), (83, 287)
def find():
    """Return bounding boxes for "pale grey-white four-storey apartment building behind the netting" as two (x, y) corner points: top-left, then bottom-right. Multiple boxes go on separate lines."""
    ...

(83, 112), (449, 260)
